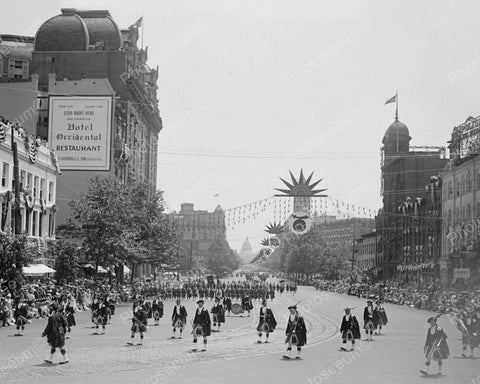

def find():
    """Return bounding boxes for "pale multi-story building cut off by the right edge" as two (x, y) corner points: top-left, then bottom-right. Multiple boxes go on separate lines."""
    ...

(441, 116), (480, 285)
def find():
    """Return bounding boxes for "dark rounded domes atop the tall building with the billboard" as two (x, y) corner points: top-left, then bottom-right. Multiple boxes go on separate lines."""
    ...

(34, 8), (123, 51)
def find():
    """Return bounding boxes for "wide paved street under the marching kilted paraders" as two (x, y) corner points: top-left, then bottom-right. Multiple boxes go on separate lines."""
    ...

(0, 287), (480, 384)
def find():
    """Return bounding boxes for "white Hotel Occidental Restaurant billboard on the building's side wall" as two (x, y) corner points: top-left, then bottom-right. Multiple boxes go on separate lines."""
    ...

(48, 96), (112, 171)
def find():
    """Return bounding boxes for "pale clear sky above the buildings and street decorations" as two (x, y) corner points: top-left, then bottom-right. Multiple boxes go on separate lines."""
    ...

(0, 0), (480, 249)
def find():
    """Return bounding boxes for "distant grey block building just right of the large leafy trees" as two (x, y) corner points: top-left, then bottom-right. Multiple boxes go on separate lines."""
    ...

(171, 203), (226, 270)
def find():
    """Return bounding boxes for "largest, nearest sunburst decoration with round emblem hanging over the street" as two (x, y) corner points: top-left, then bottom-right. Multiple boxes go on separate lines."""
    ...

(275, 169), (327, 235)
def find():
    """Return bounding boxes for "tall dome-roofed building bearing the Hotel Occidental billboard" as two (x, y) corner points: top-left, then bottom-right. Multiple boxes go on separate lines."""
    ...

(30, 8), (162, 224)
